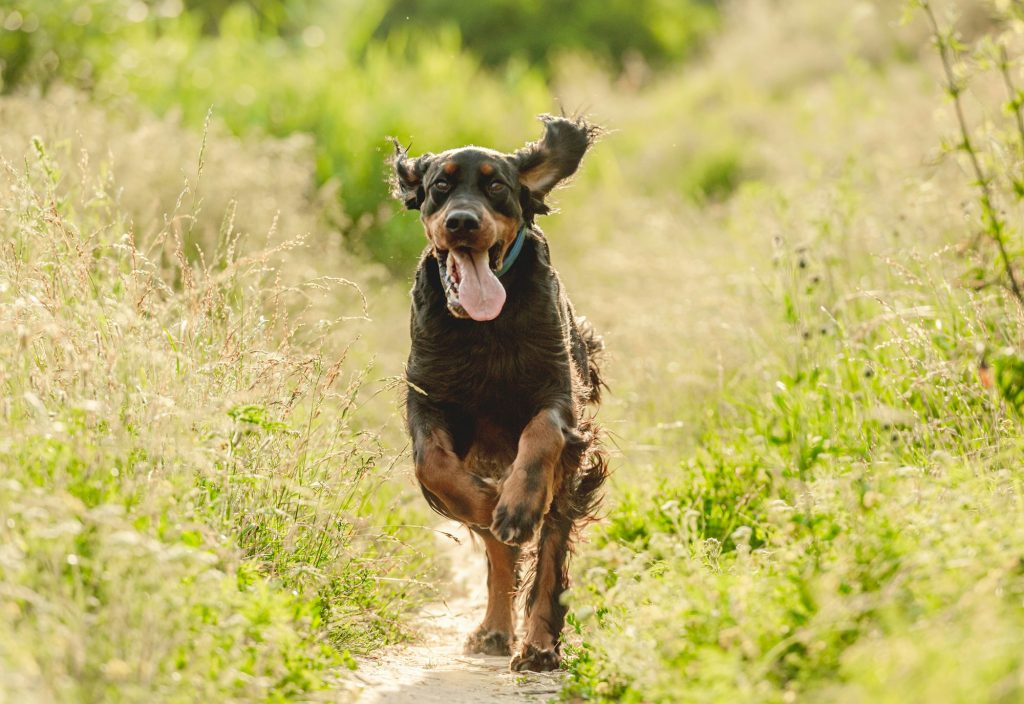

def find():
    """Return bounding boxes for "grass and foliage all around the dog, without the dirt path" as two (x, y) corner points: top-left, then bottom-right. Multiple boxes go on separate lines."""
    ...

(6, 0), (1024, 702)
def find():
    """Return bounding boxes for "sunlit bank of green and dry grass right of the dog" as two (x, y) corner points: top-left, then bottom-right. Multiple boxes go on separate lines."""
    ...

(563, 3), (1024, 702)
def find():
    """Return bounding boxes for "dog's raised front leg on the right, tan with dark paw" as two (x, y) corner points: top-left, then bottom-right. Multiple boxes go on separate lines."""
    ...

(490, 408), (566, 545)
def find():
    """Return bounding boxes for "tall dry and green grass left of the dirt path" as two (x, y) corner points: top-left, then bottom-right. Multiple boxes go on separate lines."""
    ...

(0, 100), (426, 702)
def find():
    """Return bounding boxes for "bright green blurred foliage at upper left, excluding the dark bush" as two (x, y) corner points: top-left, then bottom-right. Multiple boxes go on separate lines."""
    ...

(0, 0), (581, 269)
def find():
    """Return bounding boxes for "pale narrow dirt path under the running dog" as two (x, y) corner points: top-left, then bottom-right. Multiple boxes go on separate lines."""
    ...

(356, 524), (563, 704)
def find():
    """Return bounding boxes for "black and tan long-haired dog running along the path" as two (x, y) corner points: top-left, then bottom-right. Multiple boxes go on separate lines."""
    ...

(393, 116), (607, 670)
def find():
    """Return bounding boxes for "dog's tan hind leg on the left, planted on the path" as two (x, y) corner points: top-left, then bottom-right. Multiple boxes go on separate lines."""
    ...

(465, 531), (519, 655)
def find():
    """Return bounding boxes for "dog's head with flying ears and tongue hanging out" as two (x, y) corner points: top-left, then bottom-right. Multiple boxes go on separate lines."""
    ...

(392, 116), (600, 320)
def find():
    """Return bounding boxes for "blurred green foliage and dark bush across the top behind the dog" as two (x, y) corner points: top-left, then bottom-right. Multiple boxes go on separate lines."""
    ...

(0, 0), (716, 268)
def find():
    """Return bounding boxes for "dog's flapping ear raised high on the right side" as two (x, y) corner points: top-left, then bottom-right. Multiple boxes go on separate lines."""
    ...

(512, 115), (602, 215)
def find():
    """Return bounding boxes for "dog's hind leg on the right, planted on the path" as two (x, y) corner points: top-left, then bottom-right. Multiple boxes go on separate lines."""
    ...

(509, 510), (572, 672)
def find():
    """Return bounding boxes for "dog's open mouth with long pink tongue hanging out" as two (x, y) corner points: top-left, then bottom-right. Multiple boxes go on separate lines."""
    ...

(436, 243), (505, 321)
